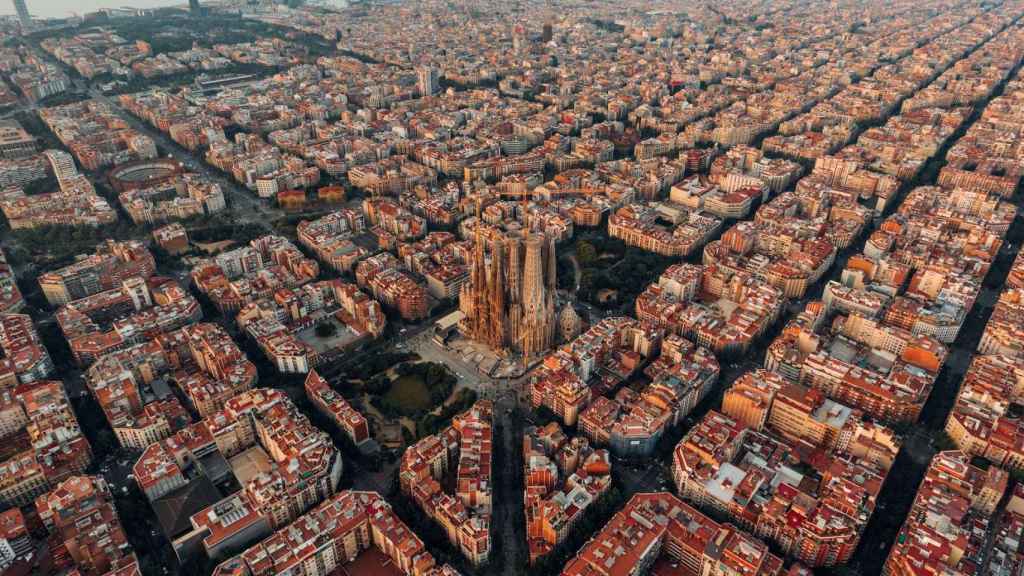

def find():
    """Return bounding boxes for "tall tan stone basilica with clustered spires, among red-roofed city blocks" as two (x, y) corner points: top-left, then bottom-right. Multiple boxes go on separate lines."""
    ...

(459, 234), (558, 358)
